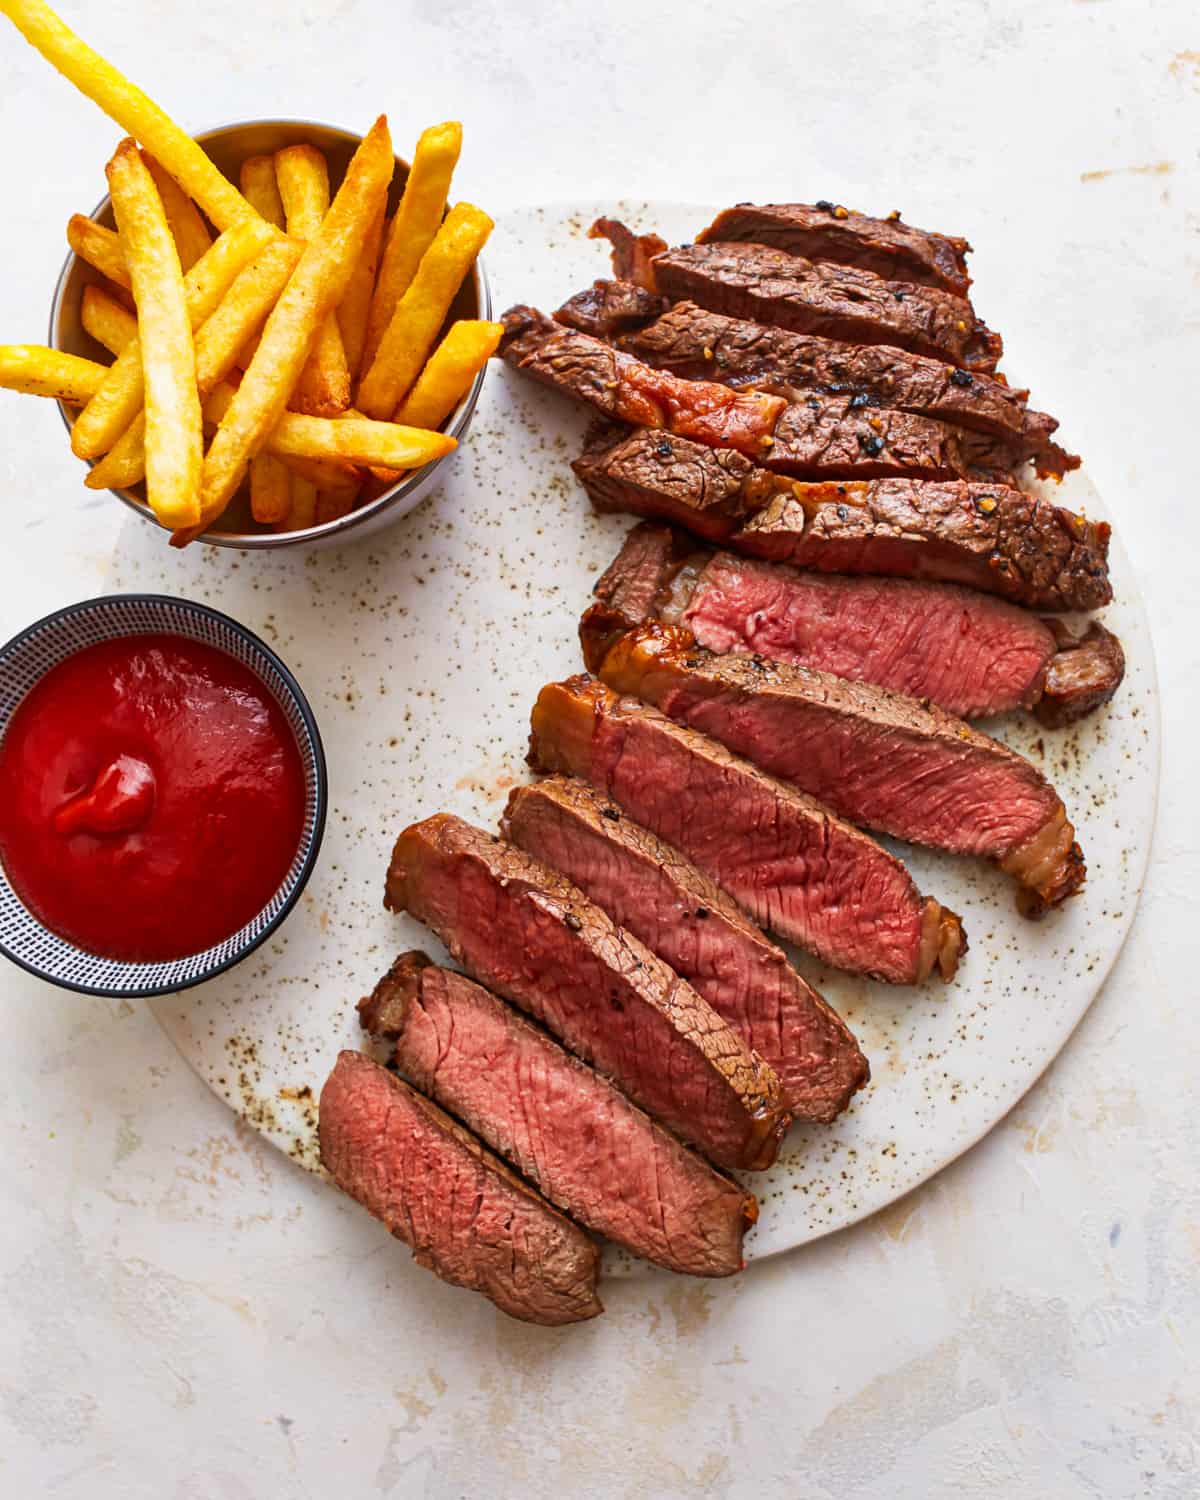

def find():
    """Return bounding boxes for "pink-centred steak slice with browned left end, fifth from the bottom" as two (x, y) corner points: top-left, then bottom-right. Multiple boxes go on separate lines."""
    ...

(530, 677), (966, 984)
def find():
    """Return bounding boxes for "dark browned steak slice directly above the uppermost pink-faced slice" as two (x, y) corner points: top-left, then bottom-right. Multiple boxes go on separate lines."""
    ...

(572, 426), (1113, 611)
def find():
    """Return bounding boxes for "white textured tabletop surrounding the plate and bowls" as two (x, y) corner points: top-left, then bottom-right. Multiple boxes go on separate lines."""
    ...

(0, 0), (1200, 1500)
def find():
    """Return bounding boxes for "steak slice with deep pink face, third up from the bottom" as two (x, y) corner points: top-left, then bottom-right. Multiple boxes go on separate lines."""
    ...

(386, 813), (788, 1169)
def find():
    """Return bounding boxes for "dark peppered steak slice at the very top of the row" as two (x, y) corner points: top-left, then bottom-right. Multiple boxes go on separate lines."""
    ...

(696, 203), (971, 297)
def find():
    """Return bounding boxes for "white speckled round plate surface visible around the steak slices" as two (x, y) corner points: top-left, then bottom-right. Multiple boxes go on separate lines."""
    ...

(110, 204), (1158, 1263)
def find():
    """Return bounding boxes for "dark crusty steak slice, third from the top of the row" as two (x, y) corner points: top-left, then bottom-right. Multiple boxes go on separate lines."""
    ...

(624, 298), (1080, 477)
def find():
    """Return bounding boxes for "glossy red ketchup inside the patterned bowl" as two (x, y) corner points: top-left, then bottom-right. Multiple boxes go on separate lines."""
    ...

(0, 635), (305, 962)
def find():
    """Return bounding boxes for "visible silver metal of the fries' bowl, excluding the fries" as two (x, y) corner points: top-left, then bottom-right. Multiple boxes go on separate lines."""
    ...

(50, 120), (492, 549)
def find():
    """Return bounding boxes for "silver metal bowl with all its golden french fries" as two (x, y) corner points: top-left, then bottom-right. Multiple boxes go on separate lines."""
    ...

(0, 0), (501, 549)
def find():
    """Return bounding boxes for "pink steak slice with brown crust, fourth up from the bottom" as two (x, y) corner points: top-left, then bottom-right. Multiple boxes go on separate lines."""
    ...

(503, 776), (870, 1122)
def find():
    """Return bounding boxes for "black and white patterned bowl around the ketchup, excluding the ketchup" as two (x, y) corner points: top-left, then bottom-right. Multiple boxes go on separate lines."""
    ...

(0, 594), (327, 999)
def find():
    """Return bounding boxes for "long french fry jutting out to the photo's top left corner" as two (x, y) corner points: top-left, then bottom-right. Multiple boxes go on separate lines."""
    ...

(0, 0), (255, 230)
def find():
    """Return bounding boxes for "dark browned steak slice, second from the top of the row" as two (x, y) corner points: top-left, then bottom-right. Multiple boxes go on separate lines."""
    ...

(654, 243), (1004, 374)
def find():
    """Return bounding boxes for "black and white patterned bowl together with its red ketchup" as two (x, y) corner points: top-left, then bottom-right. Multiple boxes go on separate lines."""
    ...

(0, 594), (326, 998)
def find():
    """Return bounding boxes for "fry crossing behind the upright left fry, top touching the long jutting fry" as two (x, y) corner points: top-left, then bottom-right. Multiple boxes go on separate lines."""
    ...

(72, 211), (275, 459)
